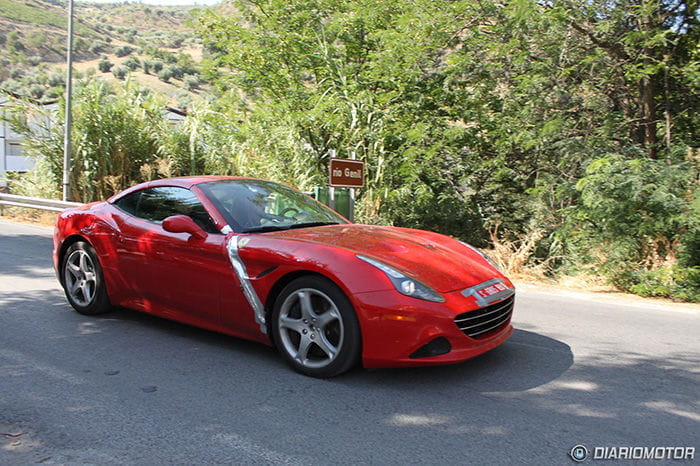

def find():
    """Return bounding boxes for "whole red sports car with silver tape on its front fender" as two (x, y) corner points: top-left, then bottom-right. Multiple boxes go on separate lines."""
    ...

(53, 176), (515, 377)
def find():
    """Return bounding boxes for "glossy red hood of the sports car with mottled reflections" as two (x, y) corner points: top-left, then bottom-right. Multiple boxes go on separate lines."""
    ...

(266, 224), (503, 293)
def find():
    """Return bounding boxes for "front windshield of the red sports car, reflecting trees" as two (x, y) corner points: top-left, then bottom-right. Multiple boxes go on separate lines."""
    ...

(199, 180), (348, 233)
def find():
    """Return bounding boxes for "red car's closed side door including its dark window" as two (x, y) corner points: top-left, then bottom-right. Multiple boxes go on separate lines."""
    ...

(110, 186), (228, 328)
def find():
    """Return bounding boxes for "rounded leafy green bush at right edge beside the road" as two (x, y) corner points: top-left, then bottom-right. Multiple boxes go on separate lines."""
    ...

(572, 154), (700, 300)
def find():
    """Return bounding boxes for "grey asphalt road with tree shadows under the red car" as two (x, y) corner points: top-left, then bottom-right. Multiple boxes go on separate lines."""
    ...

(0, 220), (700, 465)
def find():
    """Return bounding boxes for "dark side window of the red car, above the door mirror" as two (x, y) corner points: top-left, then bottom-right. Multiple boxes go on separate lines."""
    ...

(116, 186), (219, 233)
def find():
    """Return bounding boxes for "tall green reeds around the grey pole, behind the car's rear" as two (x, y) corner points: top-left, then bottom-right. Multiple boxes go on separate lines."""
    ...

(1, 80), (212, 202)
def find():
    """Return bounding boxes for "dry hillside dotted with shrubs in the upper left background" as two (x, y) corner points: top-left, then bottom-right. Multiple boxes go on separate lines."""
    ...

(0, 0), (204, 107)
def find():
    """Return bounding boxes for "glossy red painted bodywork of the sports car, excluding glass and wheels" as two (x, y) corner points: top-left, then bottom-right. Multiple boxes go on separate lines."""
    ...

(53, 177), (514, 367)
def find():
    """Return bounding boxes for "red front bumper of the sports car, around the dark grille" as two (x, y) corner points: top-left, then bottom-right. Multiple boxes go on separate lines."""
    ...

(353, 290), (513, 368)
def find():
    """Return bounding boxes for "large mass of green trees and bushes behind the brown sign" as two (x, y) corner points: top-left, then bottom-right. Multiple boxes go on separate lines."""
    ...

(190, 0), (700, 299)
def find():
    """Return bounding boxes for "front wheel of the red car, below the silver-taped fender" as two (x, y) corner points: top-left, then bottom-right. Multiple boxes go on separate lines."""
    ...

(271, 275), (361, 378)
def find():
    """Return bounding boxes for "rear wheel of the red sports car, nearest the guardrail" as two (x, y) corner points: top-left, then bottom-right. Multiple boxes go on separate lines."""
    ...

(61, 241), (112, 315)
